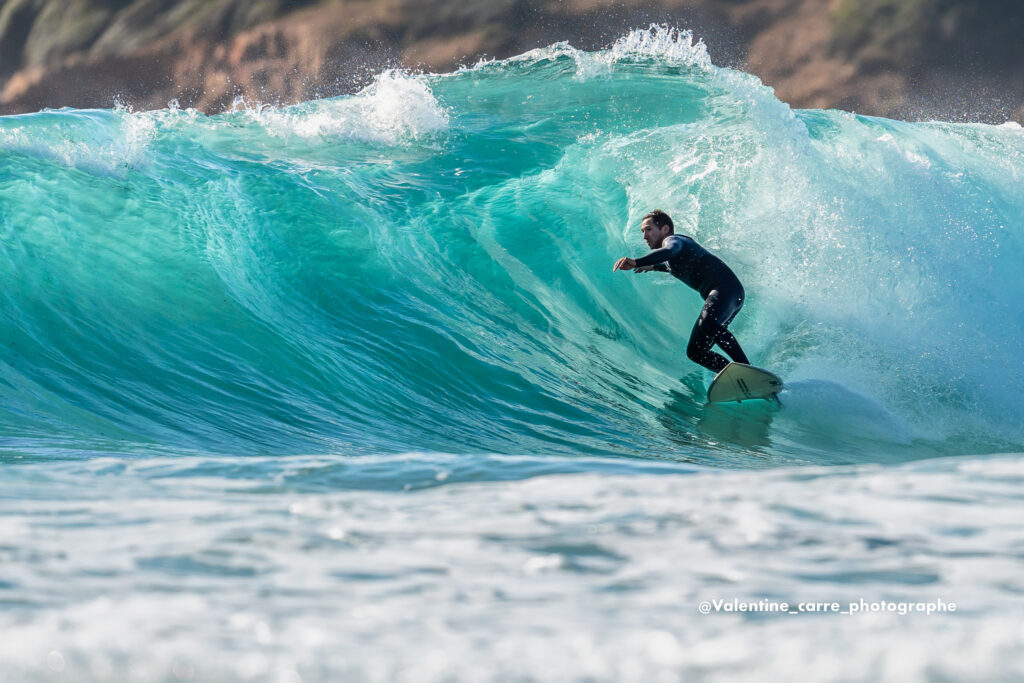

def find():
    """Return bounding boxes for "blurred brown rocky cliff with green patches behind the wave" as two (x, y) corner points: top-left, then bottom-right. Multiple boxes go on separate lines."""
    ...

(0, 0), (1024, 122)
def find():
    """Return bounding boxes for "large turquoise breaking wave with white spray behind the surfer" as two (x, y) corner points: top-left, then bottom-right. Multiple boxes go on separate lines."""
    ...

(0, 31), (1024, 464)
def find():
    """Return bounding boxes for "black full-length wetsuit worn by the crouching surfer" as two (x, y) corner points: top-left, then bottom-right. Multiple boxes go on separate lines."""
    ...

(636, 234), (750, 373)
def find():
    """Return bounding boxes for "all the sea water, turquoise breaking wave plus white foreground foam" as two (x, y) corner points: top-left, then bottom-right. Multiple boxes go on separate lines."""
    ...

(0, 28), (1024, 683)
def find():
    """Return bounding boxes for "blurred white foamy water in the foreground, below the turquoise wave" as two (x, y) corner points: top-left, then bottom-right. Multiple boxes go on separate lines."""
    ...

(0, 454), (1024, 683)
